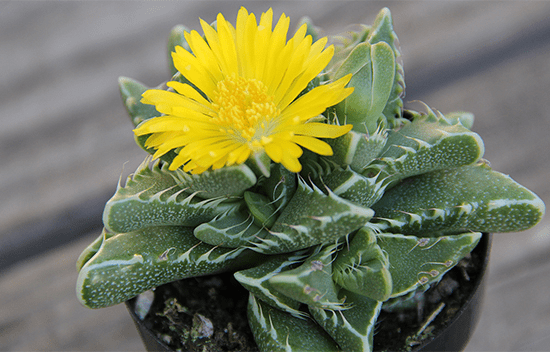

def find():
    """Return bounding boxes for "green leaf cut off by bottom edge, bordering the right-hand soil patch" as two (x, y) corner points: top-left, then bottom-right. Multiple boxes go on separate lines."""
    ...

(309, 290), (382, 352)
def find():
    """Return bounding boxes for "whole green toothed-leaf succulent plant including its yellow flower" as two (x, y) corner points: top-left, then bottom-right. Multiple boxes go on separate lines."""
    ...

(77, 9), (545, 351)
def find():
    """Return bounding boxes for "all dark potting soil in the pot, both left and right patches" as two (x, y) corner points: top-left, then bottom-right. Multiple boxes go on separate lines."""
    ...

(140, 239), (482, 352)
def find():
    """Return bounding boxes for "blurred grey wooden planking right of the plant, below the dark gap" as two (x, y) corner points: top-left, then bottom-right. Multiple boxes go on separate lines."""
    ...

(414, 17), (550, 352)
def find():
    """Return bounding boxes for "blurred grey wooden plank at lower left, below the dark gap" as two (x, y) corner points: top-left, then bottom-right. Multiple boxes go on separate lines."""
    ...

(0, 233), (144, 351)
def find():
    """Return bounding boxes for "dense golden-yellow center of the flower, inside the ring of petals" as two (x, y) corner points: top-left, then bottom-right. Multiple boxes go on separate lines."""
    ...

(212, 74), (280, 142)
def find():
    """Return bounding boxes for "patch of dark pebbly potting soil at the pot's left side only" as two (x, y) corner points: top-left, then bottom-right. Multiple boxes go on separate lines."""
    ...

(140, 274), (258, 352)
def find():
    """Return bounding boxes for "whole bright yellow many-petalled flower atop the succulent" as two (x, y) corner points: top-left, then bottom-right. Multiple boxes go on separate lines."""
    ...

(134, 8), (353, 173)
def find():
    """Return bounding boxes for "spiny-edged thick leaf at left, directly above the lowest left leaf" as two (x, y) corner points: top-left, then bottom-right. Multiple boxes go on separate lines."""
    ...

(103, 158), (235, 233)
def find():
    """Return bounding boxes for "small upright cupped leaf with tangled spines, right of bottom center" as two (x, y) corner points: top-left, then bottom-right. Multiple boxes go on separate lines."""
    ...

(333, 227), (392, 301)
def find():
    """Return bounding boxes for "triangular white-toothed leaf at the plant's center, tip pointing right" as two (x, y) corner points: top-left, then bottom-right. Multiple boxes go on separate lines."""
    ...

(256, 178), (374, 254)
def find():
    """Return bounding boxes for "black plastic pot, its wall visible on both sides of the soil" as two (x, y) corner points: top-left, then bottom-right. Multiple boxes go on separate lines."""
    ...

(126, 234), (491, 352)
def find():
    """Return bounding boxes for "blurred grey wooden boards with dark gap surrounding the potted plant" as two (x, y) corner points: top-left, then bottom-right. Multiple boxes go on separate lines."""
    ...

(0, 0), (550, 351)
